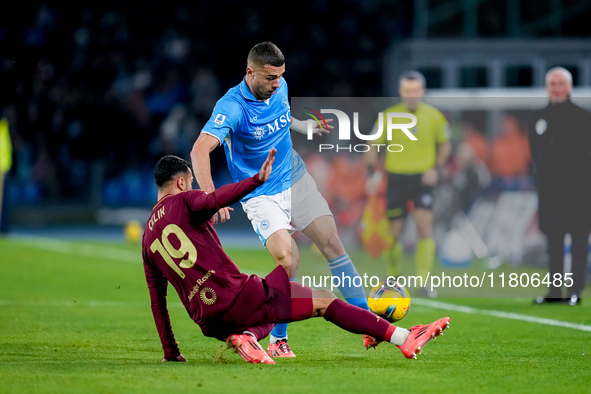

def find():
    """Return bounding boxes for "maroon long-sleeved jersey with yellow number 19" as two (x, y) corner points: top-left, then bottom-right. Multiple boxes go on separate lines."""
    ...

(142, 174), (263, 357)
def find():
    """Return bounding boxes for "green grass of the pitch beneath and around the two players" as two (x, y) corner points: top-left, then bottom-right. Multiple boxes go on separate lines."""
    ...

(0, 238), (591, 393)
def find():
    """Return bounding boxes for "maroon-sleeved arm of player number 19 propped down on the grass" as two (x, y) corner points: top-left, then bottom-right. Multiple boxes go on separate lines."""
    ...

(144, 261), (187, 362)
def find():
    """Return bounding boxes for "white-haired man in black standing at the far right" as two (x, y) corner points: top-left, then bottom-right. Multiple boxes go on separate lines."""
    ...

(529, 67), (591, 305)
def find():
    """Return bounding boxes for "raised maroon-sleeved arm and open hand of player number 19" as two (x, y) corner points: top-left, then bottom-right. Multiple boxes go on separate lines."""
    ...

(187, 148), (277, 220)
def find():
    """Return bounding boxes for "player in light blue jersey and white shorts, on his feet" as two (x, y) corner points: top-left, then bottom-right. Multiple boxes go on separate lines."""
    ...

(191, 42), (377, 357)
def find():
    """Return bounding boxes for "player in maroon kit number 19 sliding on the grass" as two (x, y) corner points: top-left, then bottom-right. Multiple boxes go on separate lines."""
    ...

(142, 148), (449, 364)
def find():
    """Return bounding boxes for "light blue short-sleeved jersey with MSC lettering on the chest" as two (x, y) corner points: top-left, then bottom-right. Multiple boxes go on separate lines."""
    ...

(202, 78), (306, 202)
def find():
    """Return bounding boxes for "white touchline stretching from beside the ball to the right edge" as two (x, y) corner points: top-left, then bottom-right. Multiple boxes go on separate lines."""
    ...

(412, 298), (591, 332)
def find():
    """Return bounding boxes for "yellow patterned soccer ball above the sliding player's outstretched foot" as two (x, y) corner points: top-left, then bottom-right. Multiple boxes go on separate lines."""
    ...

(367, 279), (410, 323)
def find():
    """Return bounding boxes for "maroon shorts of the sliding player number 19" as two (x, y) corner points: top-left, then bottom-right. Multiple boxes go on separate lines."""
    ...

(201, 266), (313, 340)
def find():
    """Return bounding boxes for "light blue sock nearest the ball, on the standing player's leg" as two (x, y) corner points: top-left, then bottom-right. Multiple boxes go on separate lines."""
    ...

(328, 254), (369, 310)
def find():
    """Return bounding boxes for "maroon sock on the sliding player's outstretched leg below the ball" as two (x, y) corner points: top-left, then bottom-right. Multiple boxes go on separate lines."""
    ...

(324, 299), (396, 342)
